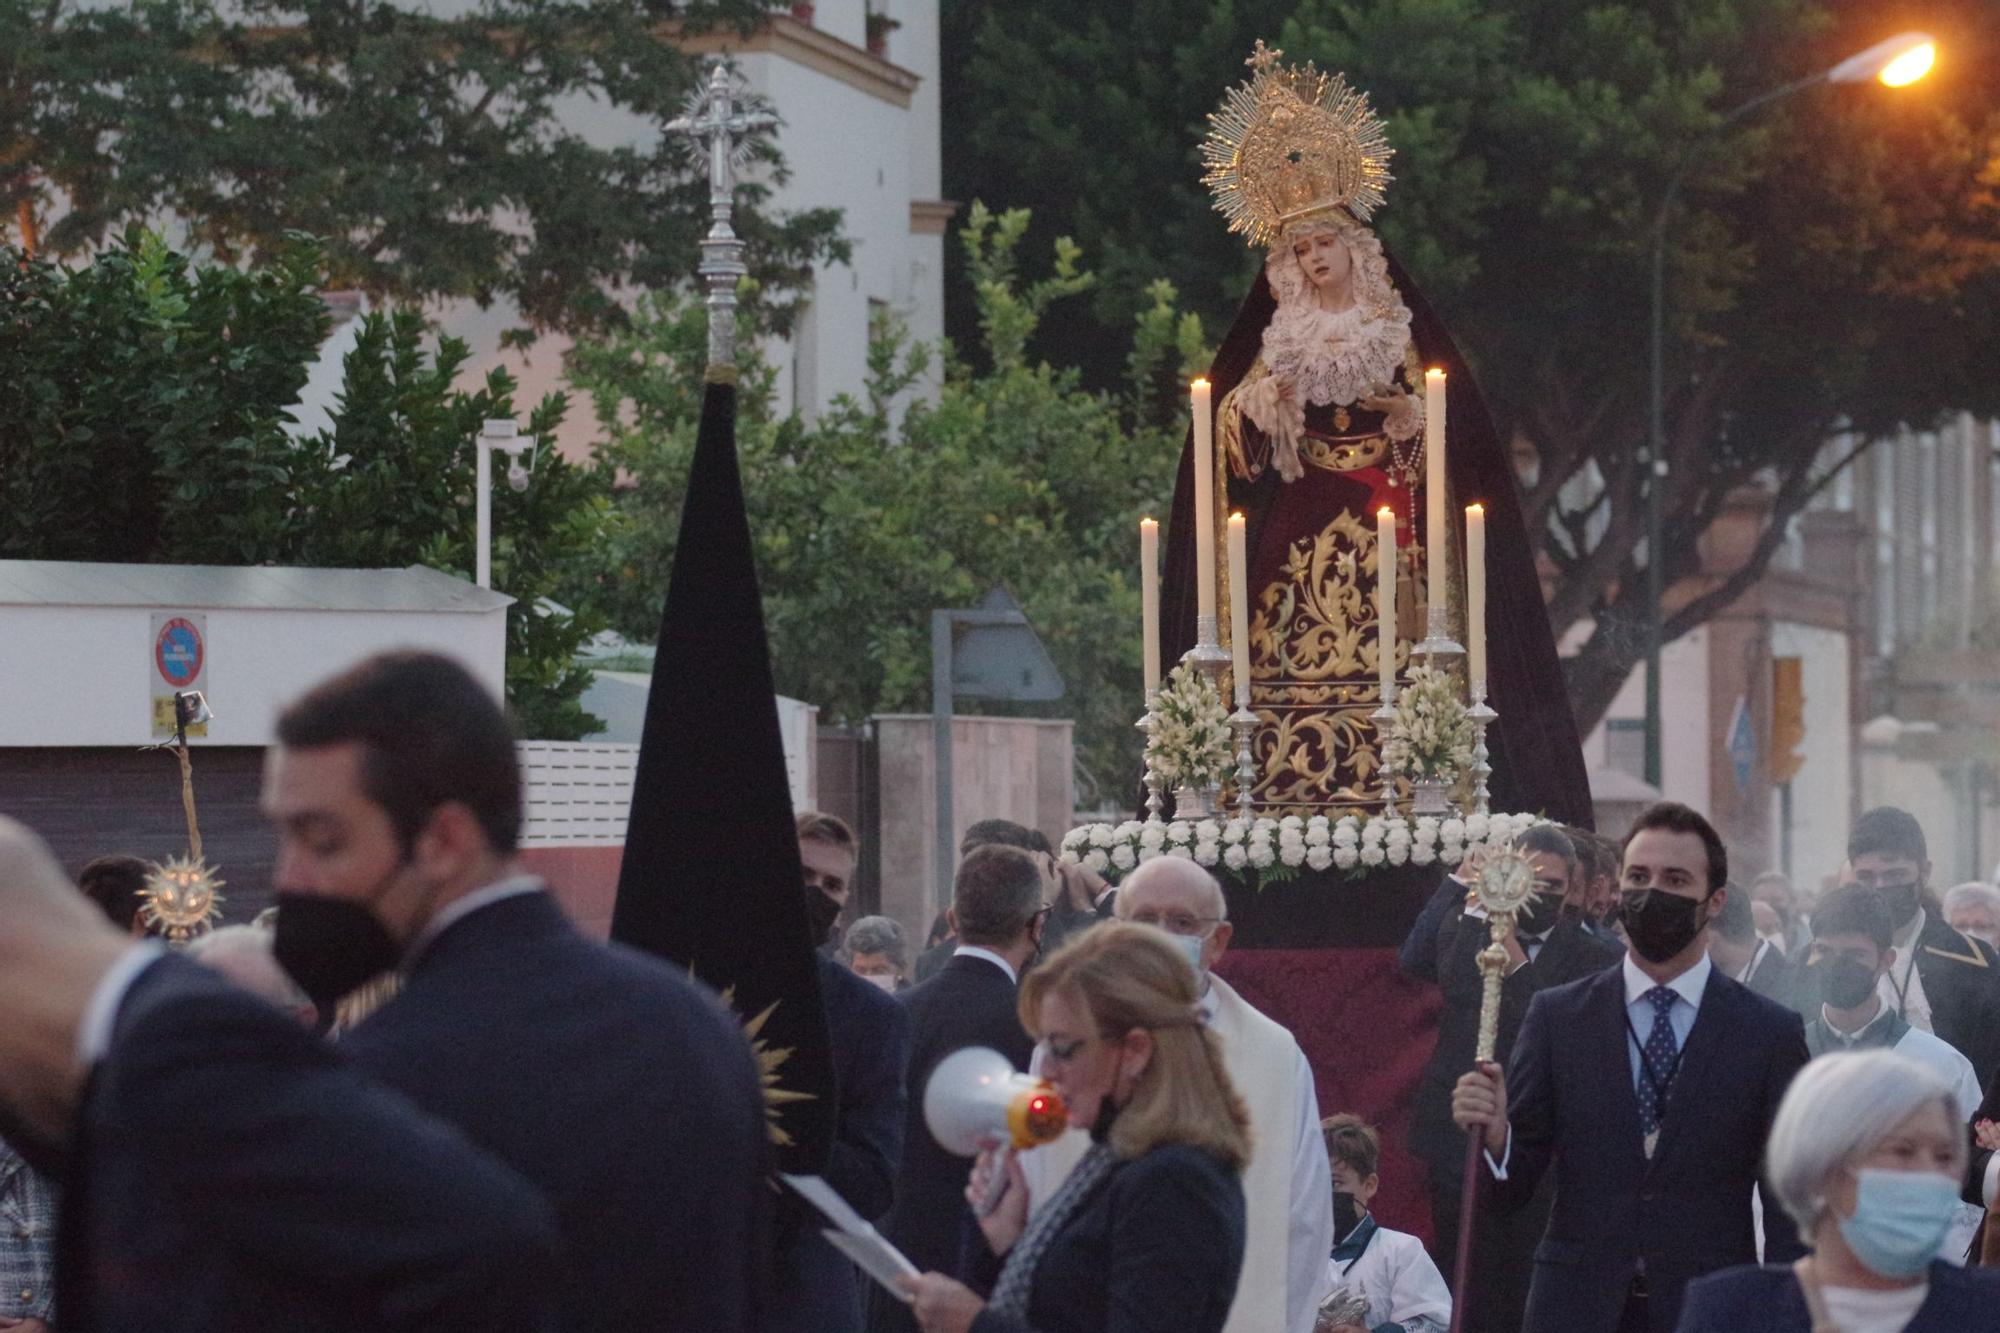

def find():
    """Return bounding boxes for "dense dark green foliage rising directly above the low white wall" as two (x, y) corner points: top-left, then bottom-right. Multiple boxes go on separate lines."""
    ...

(0, 232), (614, 741)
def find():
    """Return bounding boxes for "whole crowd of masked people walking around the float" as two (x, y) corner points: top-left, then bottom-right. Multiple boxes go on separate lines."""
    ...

(0, 654), (2000, 1333)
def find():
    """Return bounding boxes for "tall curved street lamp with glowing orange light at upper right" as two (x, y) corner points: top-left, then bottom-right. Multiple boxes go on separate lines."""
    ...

(1644, 32), (1938, 787)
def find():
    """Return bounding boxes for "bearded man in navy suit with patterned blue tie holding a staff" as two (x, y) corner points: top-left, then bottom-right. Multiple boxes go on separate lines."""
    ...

(1452, 803), (1806, 1333)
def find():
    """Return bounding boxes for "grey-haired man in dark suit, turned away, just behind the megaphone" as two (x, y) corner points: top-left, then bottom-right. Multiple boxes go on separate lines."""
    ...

(868, 845), (1046, 1333)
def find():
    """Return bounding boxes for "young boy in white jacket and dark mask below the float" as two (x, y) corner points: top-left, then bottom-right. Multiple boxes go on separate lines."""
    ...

(1318, 1115), (1452, 1333)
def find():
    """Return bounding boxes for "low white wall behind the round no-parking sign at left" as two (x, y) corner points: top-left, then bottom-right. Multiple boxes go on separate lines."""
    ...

(0, 606), (506, 747)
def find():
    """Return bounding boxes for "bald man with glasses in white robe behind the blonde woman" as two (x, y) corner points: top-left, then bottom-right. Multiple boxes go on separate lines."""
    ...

(1022, 857), (1334, 1333)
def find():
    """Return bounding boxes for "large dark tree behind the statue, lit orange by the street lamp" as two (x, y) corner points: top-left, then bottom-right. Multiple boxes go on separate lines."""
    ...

(944, 0), (2000, 725)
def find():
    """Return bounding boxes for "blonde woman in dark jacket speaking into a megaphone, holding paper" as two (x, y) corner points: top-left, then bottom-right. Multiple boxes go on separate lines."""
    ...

(904, 925), (1250, 1333)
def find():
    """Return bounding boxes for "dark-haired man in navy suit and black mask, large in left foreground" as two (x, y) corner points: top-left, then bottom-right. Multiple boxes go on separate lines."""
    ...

(264, 652), (770, 1333)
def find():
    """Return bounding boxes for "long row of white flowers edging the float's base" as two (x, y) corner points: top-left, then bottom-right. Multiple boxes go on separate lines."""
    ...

(1062, 815), (1540, 883)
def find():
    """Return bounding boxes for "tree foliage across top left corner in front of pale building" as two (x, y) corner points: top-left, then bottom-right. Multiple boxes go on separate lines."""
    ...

(0, 0), (846, 342)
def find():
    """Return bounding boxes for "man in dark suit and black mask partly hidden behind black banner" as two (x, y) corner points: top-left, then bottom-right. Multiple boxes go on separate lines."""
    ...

(762, 811), (910, 1333)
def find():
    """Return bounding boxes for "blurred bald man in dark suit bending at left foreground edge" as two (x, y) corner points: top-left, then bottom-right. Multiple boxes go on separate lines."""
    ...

(0, 819), (558, 1333)
